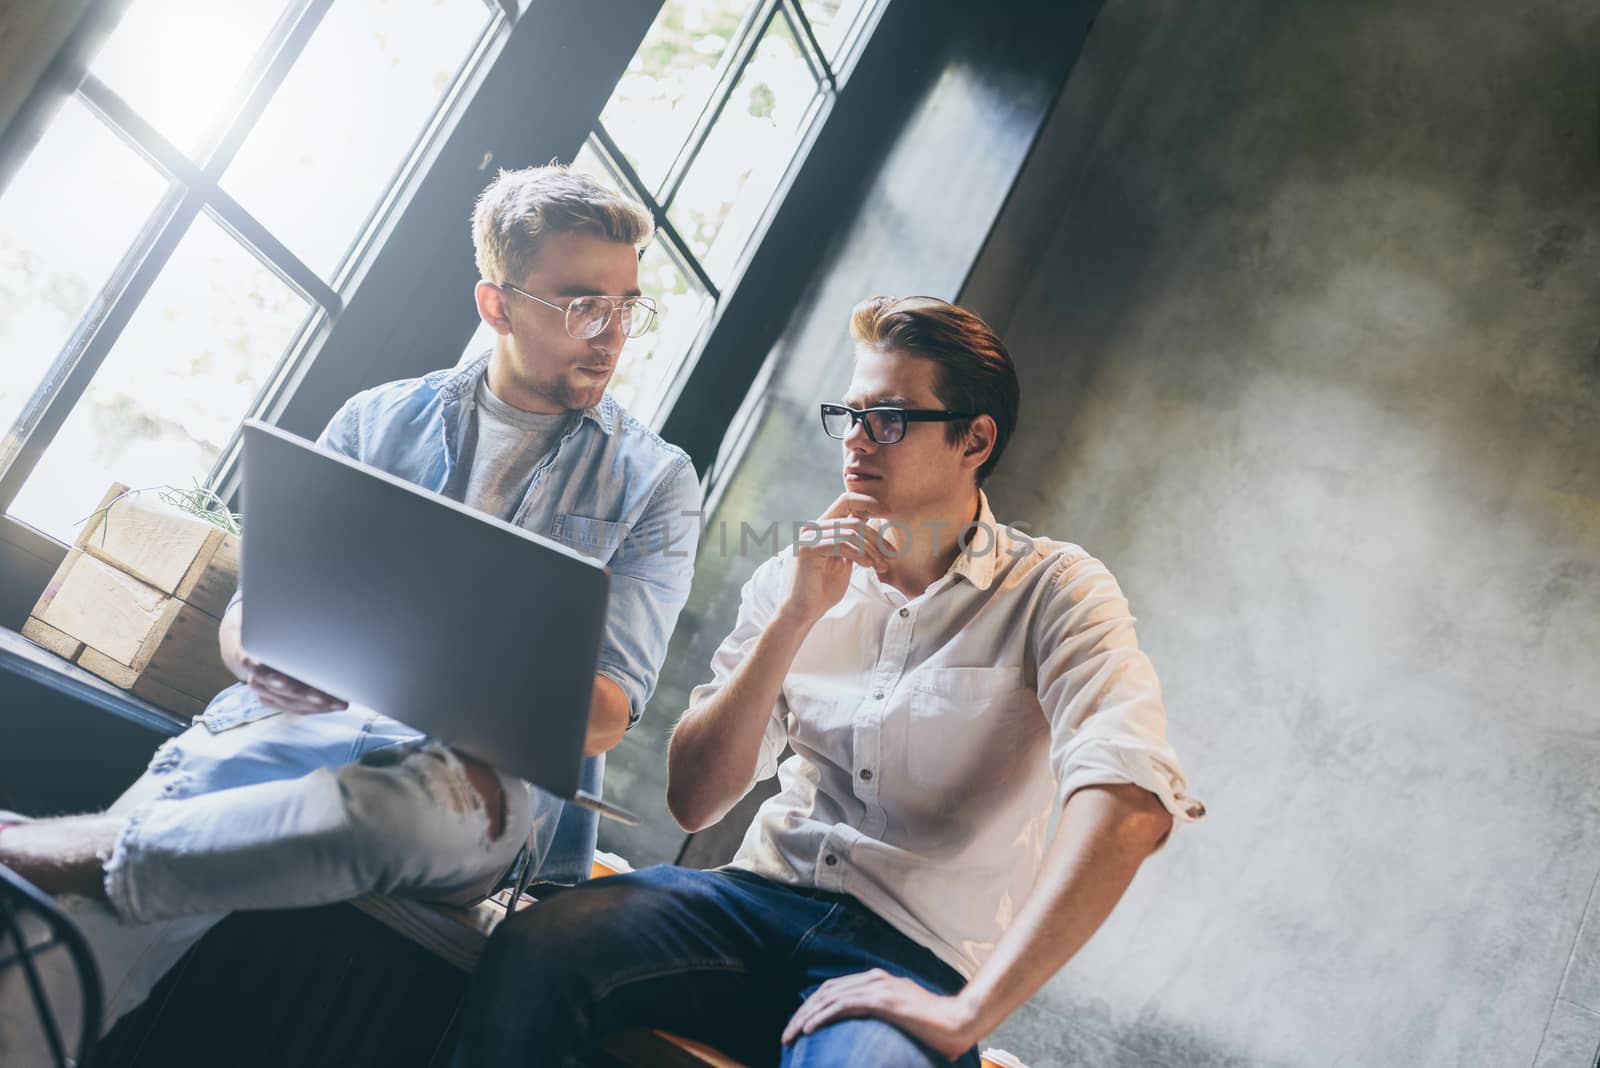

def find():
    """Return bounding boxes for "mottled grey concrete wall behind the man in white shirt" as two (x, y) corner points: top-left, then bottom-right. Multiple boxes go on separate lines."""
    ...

(966, 0), (1600, 1068)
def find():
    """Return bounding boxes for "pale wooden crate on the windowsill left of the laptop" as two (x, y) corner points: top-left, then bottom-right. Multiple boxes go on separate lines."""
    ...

(22, 486), (238, 716)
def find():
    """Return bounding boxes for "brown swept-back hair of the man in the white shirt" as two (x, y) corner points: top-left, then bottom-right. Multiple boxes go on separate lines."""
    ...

(850, 297), (1021, 486)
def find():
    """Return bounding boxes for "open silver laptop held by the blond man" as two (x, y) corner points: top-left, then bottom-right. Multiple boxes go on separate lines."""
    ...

(240, 419), (635, 822)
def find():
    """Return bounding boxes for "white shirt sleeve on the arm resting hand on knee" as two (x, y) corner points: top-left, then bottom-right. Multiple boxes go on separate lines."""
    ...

(1034, 556), (1205, 822)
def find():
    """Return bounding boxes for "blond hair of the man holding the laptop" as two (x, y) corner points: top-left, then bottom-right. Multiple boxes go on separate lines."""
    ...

(472, 163), (656, 283)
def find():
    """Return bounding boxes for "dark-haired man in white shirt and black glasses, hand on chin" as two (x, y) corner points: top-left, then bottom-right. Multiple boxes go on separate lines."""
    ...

(458, 297), (1203, 1068)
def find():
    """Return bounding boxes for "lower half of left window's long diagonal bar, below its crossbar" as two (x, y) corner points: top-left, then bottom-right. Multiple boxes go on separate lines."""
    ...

(0, 185), (202, 512)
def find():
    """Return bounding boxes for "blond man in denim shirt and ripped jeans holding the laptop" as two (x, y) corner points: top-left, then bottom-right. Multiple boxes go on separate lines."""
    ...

(0, 166), (699, 1049)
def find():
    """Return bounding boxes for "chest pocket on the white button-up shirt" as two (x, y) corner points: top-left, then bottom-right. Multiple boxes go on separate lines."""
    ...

(906, 667), (1038, 793)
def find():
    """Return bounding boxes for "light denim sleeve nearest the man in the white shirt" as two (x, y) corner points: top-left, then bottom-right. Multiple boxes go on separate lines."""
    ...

(598, 456), (701, 727)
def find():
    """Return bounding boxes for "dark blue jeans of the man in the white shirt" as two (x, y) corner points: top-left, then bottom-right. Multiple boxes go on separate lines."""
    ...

(456, 867), (979, 1068)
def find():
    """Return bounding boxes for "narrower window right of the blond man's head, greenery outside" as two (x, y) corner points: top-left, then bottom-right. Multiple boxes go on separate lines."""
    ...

(467, 0), (875, 425)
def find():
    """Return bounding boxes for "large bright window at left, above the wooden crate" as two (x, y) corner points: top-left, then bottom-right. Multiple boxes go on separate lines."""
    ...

(0, 0), (507, 540)
